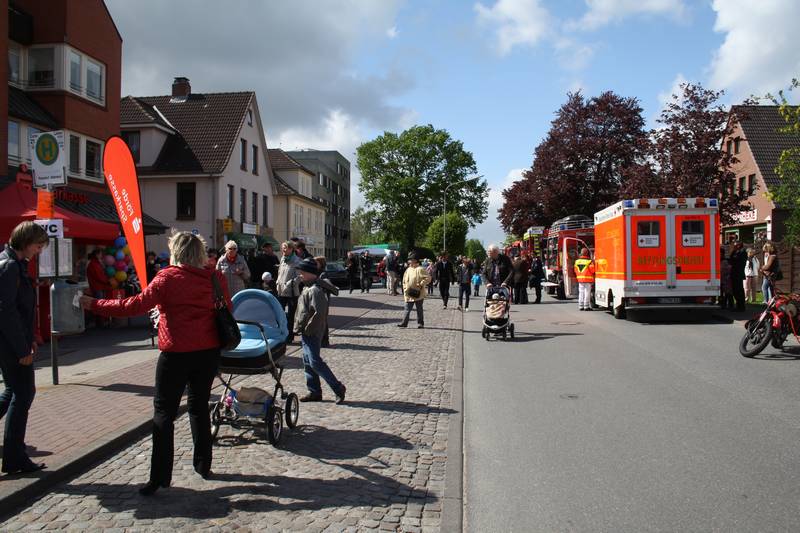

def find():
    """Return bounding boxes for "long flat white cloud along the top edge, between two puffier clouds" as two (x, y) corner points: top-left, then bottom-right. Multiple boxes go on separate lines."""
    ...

(567, 0), (686, 31)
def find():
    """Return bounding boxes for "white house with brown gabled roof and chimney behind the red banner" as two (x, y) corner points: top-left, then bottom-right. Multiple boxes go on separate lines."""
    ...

(120, 77), (275, 252)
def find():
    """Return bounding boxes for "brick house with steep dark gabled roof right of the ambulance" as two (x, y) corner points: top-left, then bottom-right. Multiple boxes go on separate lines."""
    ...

(723, 105), (800, 243)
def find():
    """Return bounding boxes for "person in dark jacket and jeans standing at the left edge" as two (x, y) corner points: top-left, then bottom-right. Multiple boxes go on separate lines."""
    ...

(0, 221), (47, 474)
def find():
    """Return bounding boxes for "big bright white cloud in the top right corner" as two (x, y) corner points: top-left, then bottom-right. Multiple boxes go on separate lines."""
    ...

(710, 0), (800, 97)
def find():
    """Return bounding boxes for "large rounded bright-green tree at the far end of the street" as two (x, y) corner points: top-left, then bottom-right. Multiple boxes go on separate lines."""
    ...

(356, 125), (489, 250)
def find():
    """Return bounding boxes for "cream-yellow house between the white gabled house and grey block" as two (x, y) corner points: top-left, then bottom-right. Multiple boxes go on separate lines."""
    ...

(269, 148), (326, 256)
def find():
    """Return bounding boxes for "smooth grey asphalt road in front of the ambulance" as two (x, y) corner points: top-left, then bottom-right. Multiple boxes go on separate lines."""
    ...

(464, 297), (800, 532)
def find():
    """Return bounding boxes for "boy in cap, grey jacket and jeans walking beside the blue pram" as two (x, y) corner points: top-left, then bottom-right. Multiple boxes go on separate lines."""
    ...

(292, 259), (347, 404)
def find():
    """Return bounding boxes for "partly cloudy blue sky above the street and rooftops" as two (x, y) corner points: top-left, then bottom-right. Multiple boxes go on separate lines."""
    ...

(106, 0), (800, 245)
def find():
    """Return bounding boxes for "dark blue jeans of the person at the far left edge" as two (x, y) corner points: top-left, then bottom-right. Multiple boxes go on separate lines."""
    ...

(0, 354), (36, 472)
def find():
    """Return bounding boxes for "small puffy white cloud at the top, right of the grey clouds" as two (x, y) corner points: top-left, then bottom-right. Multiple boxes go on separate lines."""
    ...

(475, 0), (553, 55)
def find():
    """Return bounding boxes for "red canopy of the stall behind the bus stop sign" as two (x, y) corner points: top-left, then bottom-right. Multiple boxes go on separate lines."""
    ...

(0, 183), (119, 243)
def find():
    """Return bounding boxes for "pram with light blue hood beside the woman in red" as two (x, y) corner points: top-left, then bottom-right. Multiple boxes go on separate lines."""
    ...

(209, 289), (300, 446)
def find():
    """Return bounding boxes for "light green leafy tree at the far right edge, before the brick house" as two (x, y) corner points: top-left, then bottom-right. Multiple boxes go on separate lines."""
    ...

(768, 79), (800, 246)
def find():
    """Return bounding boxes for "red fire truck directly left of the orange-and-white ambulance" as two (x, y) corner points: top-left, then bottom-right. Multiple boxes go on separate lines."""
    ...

(542, 215), (594, 300)
